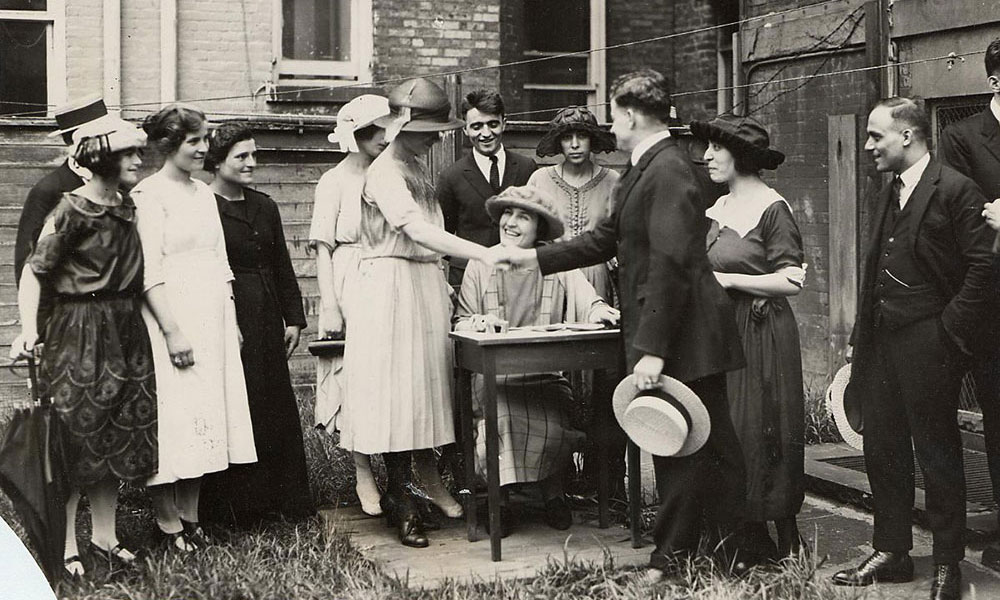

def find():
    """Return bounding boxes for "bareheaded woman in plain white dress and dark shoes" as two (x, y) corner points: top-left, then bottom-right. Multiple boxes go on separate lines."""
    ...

(132, 104), (257, 552)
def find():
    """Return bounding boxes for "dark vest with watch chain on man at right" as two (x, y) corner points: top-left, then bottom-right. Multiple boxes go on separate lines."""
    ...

(873, 200), (948, 329)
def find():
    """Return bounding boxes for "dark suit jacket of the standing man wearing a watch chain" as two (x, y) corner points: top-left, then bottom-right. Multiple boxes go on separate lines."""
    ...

(851, 160), (993, 368)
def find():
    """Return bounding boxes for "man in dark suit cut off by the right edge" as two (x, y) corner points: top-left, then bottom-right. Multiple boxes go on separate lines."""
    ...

(939, 38), (1000, 571)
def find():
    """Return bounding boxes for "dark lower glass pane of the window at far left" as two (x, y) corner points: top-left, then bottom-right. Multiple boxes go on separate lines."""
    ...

(0, 21), (48, 114)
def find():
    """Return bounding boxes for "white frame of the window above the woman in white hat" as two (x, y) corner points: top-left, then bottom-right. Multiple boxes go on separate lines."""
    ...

(271, 0), (374, 85)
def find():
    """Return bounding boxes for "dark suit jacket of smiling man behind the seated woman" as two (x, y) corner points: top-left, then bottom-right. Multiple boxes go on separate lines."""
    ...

(437, 150), (538, 267)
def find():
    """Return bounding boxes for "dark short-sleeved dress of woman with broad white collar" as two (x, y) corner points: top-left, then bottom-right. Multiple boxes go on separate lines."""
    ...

(708, 196), (805, 521)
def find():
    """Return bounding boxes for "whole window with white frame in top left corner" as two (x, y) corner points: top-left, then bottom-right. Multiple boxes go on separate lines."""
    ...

(0, 0), (65, 116)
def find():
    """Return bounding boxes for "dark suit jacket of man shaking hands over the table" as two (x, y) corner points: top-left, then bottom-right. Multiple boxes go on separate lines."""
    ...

(538, 137), (744, 381)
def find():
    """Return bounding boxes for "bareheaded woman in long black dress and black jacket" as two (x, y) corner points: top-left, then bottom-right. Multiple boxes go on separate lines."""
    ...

(199, 124), (316, 525)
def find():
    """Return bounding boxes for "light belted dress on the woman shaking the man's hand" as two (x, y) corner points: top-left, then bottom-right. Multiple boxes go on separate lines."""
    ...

(340, 151), (455, 454)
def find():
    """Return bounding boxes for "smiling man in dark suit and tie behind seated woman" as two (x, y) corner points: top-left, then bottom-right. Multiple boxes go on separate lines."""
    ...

(437, 90), (536, 287)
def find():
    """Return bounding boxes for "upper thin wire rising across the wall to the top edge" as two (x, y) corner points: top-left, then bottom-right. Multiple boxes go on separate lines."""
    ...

(0, 0), (841, 117)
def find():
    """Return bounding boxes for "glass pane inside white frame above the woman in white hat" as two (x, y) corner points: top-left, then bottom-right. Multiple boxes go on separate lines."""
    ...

(281, 0), (351, 62)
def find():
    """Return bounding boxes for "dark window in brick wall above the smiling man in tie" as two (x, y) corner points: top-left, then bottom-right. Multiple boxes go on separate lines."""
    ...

(524, 0), (606, 121)
